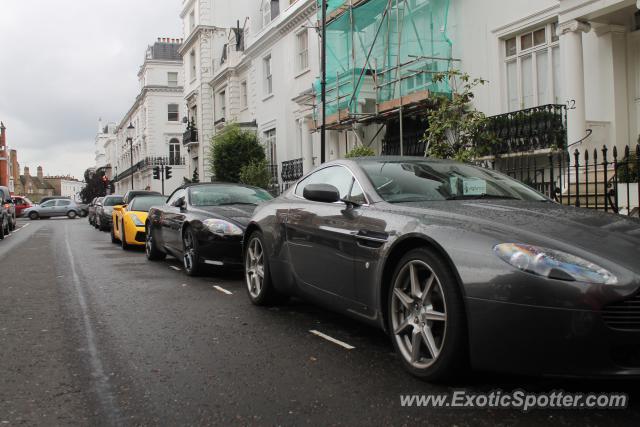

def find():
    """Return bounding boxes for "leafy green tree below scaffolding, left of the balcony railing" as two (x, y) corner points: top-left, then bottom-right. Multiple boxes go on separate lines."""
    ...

(423, 70), (493, 161)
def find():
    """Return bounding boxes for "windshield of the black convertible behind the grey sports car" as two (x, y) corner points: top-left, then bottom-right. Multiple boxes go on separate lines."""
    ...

(189, 184), (273, 206)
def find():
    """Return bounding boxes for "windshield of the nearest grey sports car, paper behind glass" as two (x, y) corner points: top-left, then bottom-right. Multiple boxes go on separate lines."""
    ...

(361, 160), (548, 203)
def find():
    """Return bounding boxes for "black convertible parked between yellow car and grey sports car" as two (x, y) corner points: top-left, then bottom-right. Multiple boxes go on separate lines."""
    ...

(145, 184), (272, 276)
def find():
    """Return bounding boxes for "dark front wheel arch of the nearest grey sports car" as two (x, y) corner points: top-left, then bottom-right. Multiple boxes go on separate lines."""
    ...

(378, 234), (467, 332)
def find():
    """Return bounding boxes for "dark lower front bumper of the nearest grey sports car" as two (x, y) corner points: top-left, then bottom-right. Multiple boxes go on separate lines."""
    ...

(466, 298), (640, 377)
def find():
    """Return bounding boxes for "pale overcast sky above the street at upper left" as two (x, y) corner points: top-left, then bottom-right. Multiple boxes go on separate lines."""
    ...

(0, 0), (182, 178)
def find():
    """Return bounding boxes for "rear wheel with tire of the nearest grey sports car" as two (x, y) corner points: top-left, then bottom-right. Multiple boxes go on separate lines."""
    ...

(243, 231), (286, 306)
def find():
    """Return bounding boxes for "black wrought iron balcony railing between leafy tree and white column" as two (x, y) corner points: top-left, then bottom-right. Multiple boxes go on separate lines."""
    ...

(488, 104), (567, 155)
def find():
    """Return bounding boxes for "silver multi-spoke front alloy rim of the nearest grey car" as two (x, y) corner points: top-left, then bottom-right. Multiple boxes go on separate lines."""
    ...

(391, 260), (447, 369)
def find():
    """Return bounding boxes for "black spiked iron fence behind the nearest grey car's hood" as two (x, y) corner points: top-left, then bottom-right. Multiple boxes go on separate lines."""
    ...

(480, 144), (640, 216)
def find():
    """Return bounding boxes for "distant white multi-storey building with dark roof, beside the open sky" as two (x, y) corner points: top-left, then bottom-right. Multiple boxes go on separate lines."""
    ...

(114, 38), (187, 194)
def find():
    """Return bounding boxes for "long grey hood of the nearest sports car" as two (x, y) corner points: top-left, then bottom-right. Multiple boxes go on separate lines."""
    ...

(395, 200), (640, 273)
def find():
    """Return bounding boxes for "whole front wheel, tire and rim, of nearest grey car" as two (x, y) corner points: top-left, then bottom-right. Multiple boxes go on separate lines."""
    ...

(387, 248), (468, 381)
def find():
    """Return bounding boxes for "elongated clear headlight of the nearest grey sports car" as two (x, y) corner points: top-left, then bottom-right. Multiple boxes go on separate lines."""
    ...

(493, 243), (618, 285)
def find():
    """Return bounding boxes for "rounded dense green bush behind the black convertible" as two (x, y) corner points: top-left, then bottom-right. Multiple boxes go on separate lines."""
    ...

(208, 123), (266, 182)
